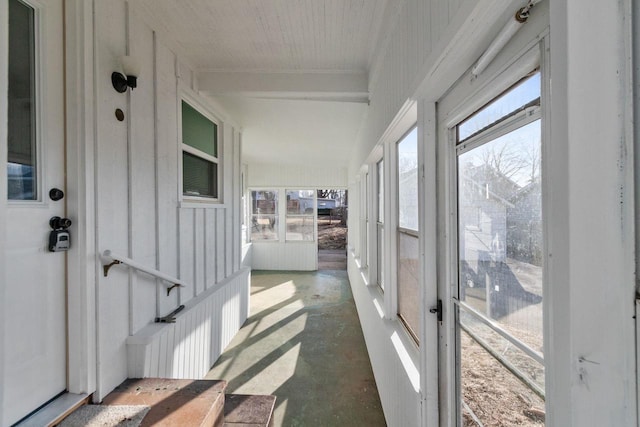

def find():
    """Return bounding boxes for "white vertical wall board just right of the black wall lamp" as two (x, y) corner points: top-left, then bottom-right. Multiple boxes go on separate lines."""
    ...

(127, 9), (156, 331)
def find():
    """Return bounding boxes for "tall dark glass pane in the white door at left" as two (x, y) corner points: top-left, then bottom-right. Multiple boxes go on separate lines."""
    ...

(7, 0), (38, 200)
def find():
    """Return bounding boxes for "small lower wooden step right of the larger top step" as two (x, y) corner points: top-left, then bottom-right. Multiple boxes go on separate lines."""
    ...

(224, 394), (276, 427)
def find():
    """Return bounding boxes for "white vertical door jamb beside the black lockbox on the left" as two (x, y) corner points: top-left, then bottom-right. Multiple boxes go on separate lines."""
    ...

(63, 0), (100, 394)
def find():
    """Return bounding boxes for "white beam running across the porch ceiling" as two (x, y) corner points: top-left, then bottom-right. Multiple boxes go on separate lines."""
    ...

(196, 71), (369, 103)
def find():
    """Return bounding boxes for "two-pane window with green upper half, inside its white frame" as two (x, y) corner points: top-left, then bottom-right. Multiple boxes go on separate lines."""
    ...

(182, 101), (219, 199)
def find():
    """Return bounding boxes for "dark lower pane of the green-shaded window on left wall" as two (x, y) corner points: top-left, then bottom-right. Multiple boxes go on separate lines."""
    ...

(182, 152), (218, 198)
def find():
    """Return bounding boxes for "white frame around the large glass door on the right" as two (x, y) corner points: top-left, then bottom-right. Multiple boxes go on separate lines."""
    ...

(435, 10), (550, 427)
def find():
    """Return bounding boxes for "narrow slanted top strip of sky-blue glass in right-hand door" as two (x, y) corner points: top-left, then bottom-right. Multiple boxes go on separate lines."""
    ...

(458, 72), (540, 142)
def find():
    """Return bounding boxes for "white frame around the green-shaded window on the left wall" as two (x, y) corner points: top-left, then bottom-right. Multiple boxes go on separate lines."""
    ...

(177, 88), (225, 208)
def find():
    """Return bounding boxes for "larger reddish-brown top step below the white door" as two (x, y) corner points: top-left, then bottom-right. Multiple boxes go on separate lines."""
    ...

(102, 378), (227, 427)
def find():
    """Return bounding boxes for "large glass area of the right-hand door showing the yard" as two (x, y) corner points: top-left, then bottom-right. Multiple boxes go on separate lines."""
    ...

(451, 71), (545, 426)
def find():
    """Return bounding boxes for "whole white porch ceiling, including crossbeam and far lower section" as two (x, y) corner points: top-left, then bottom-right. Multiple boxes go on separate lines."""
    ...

(129, 0), (389, 171)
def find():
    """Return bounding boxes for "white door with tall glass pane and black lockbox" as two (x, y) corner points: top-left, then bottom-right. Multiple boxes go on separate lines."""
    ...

(0, 0), (67, 425)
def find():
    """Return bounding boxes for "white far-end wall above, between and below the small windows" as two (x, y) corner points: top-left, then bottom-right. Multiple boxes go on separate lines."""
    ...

(247, 163), (347, 271)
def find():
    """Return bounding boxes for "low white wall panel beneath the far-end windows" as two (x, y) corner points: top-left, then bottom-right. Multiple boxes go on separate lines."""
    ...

(252, 242), (318, 271)
